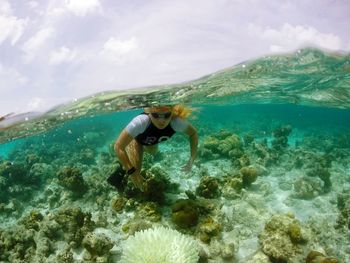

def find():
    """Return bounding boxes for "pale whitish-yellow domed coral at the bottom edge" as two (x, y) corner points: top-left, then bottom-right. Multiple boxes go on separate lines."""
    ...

(121, 227), (199, 263)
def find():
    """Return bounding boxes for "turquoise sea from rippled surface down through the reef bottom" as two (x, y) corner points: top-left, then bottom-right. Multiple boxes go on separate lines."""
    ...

(0, 49), (350, 262)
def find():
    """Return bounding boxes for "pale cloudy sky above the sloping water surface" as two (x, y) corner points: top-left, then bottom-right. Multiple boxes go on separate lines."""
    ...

(0, 0), (350, 116)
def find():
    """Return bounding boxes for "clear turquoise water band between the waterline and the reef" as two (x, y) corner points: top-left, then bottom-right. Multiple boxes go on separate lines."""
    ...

(0, 104), (350, 162)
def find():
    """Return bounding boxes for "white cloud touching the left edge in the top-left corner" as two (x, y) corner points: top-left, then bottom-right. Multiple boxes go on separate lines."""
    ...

(0, 1), (27, 45)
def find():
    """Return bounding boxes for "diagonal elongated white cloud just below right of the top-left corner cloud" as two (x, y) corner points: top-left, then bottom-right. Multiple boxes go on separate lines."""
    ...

(23, 27), (55, 62)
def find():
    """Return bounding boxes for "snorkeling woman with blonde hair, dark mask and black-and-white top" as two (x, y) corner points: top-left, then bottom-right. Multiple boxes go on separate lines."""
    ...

(114, 105), (198, 190)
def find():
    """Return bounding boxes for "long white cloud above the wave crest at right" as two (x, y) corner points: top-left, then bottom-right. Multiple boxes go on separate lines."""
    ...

(250, 23), (343, 52)
